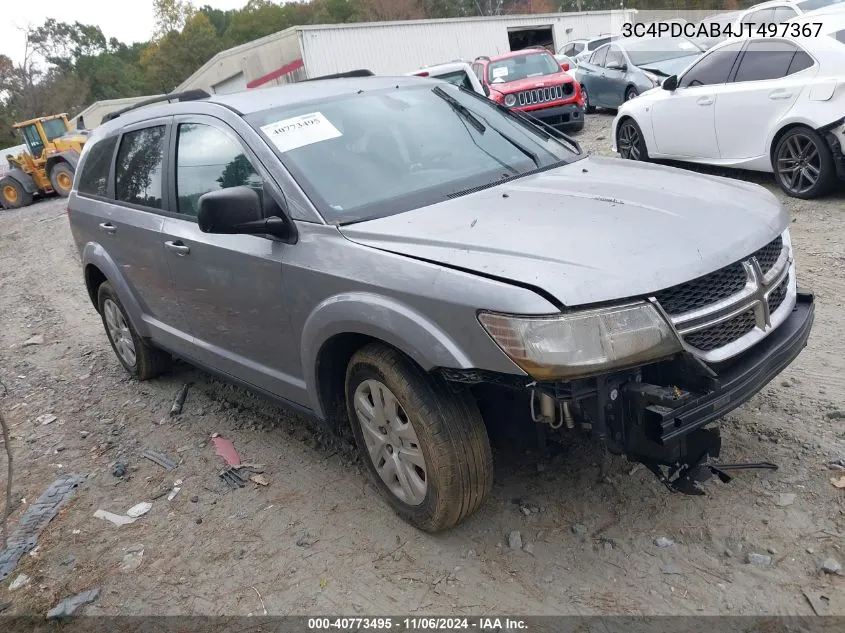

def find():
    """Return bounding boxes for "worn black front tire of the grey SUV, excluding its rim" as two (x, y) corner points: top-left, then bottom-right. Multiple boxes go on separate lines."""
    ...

(346, 344), (493, 532)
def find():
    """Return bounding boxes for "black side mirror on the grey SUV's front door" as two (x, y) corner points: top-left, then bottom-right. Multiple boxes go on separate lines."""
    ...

(197, 187), (292, 239)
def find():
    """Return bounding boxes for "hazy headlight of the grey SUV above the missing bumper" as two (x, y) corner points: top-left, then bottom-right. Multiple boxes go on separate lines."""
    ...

(478, 302), (681, 380)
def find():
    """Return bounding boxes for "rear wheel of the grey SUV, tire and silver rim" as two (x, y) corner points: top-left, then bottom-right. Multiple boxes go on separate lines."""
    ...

(97, 281), (171, 380)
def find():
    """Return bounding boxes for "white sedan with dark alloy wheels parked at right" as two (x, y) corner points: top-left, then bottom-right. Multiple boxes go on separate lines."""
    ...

(612, 29), (845, 198)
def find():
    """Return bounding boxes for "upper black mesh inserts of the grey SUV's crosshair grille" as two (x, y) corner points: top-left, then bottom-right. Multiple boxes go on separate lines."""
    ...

(655, 236), (783, 316)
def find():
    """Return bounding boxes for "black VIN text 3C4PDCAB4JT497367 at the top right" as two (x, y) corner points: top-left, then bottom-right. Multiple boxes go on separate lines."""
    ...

(622, 21), (822, 39)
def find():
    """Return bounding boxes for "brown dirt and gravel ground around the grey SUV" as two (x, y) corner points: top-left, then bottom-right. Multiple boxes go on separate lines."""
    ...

(0, 114), (845, 615)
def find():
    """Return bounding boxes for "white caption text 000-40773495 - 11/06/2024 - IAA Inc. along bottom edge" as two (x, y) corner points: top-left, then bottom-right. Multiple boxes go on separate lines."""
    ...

(308, 617), (528, 633)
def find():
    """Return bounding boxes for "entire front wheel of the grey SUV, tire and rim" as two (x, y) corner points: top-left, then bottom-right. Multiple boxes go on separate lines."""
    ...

(346, 344), (493, 532)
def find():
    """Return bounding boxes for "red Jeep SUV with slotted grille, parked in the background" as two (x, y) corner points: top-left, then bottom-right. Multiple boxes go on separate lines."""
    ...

(472, 49), (584, 131)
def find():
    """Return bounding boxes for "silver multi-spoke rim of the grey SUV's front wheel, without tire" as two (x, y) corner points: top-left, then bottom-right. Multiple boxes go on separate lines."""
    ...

(353, 380), (428, 506)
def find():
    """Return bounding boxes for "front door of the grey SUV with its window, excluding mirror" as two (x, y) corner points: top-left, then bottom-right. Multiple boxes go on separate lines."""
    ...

(162, 115), (302, 401)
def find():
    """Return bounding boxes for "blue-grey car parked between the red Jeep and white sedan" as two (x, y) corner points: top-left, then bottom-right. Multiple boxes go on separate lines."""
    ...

(574, 37), (704, 112)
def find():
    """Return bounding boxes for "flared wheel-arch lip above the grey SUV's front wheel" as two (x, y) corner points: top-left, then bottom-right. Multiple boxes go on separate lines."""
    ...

(300, 292), (472, 417)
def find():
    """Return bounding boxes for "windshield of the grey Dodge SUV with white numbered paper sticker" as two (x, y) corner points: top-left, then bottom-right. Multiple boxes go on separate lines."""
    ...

(246, 82), (580, 223)
